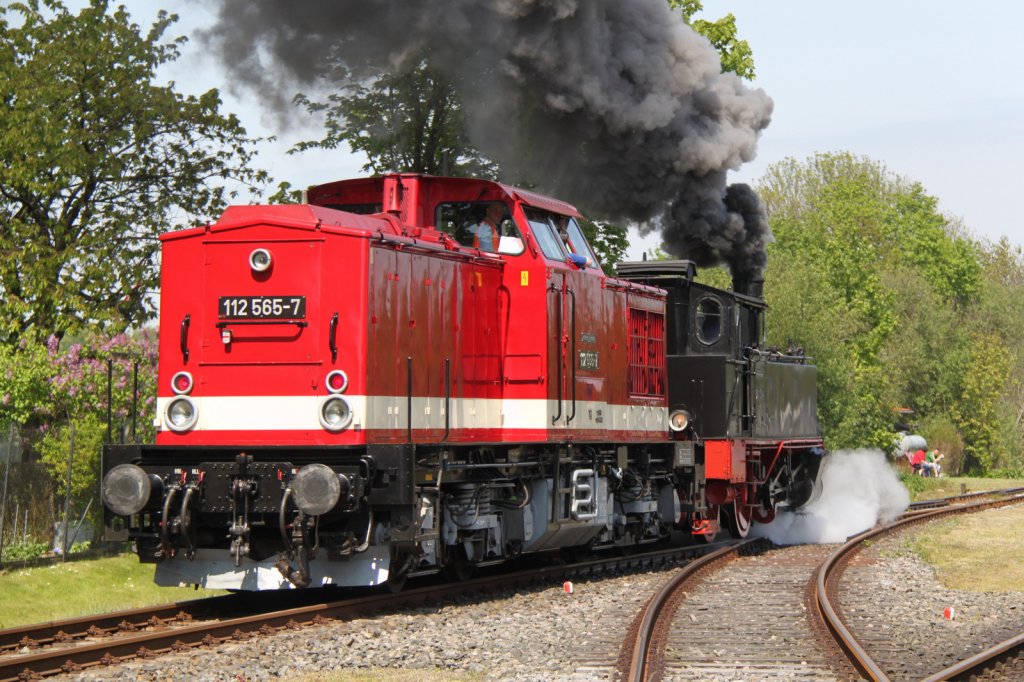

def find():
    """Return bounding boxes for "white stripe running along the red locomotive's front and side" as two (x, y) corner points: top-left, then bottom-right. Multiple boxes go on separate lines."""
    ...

(149, 394), (669, 434)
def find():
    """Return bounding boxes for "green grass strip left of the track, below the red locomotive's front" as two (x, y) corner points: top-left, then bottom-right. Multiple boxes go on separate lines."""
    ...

(0, 554), (224, 628)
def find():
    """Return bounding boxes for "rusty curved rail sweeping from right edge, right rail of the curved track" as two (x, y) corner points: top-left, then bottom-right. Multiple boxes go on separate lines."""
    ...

(815, 488), (1024, 682)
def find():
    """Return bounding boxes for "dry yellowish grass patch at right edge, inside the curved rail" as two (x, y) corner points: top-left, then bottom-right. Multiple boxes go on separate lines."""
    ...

(910, 506), (1024, 592)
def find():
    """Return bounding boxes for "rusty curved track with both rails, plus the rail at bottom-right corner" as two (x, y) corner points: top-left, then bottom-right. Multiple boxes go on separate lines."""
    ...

(617, 488), (1024, 681)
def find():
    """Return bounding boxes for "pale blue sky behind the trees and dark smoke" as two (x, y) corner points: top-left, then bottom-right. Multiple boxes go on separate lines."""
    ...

(121, 0), (1024, 257)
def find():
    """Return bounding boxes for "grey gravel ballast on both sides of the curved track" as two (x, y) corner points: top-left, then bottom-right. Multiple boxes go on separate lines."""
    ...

(56, 516), (1024, 682)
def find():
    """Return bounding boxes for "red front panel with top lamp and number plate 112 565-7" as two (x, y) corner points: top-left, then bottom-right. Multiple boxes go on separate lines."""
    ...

(201, 236), (323, 365)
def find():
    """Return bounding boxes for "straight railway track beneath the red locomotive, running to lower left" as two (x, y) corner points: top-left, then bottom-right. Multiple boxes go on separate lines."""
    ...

(0, 546), (714, 682)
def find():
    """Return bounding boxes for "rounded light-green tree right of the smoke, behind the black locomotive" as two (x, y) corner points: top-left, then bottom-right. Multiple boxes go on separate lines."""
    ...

(759, 154), (983, 450)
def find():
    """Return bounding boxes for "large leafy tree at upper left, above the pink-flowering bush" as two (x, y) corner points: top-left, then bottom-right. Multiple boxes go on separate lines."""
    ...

(0, 0), (266, 342)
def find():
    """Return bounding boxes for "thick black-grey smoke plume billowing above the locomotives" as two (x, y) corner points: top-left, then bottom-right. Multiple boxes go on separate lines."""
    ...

(204, 0), (772, 275)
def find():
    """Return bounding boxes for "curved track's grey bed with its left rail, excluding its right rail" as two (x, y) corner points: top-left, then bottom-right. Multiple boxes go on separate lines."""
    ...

(618, 540), (836, 682)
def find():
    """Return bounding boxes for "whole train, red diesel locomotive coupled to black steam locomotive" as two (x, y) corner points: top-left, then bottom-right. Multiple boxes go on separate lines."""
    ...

(102, 174), (824, 590)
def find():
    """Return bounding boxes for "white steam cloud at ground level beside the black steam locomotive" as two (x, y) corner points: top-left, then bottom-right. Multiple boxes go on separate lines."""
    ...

(752, 450), (910, 545)
